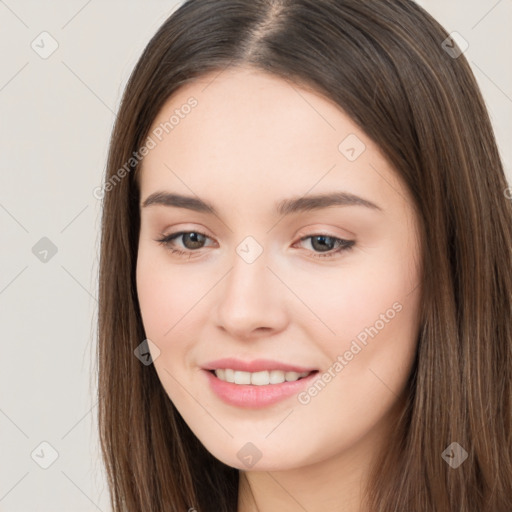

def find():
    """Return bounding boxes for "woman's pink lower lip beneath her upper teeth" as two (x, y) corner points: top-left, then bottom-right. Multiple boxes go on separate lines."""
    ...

(203, 370), (318, 409)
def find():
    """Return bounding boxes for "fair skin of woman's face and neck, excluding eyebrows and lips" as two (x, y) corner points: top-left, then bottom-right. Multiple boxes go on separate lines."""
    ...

(137, 68), (421, 512)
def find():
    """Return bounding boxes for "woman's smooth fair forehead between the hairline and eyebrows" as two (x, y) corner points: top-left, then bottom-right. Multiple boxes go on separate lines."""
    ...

(141, 68), (410, 216)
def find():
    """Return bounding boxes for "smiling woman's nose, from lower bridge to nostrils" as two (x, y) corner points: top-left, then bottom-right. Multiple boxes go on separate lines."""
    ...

(215, 244), (288, 339)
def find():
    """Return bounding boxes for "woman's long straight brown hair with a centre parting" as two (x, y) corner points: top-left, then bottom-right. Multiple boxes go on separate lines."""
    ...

(98, 0), (512, 512)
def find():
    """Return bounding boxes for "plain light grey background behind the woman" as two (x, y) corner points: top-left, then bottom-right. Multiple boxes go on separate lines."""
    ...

(0, 0), (512, 512)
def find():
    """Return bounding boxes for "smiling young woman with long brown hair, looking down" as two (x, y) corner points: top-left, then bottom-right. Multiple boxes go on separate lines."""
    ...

(98, 0), (512, 512)
